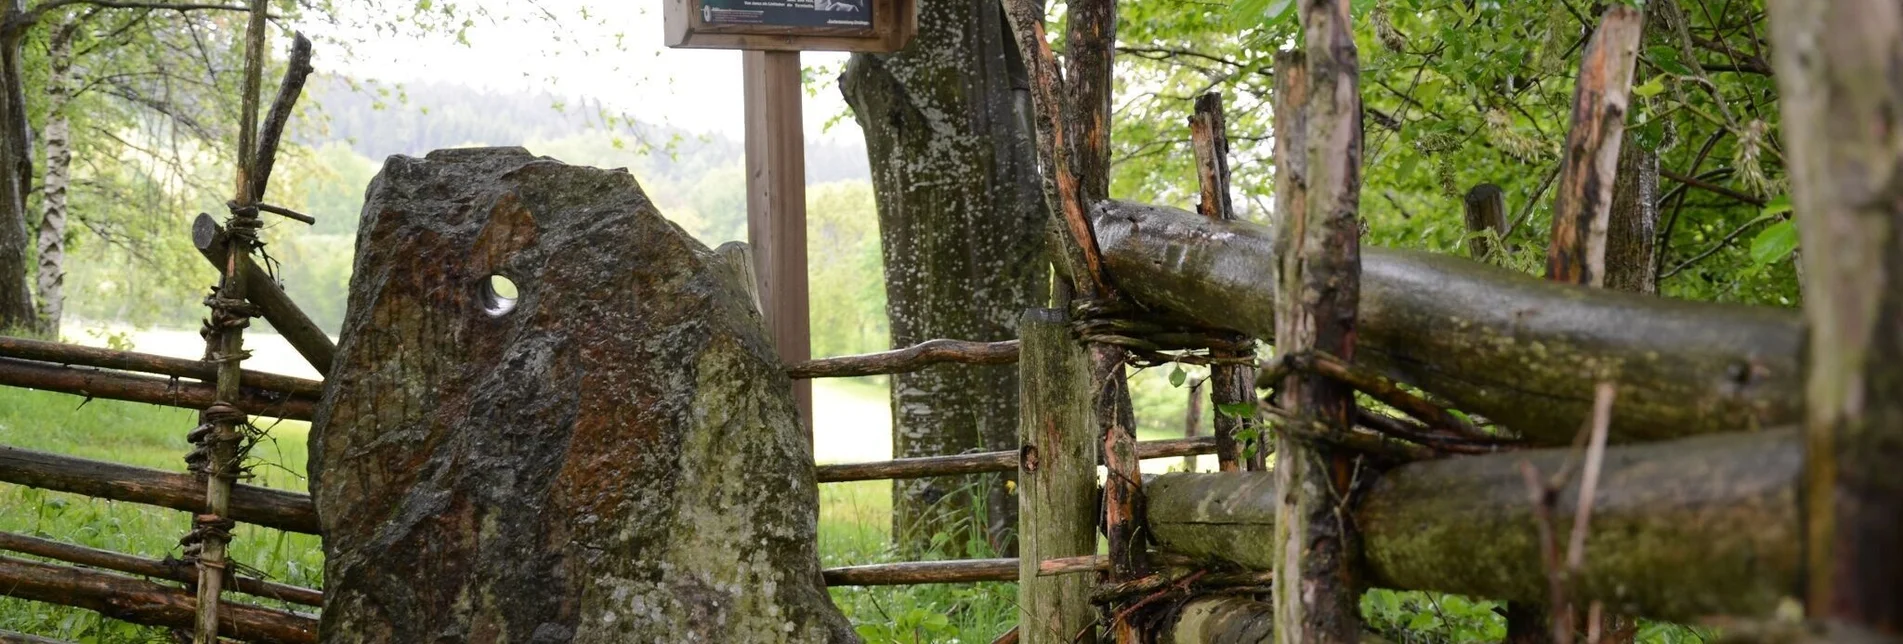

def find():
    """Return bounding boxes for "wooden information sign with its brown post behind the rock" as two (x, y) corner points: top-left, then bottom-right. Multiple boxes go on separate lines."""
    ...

(664, 0), (917, 434)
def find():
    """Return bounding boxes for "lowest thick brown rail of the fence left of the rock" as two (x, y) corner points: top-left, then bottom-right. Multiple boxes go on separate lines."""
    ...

(0, 556), (318, 642)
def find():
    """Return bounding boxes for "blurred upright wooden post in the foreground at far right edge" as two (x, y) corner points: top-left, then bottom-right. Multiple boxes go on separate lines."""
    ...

(1770, 0), (1903, 638)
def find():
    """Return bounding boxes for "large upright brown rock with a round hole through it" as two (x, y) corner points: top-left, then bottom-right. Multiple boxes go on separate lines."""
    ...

(310, 149), (854, 642)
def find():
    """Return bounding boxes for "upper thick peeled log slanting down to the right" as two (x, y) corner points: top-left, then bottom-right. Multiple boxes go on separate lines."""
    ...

(1094, 202), (1804, 444)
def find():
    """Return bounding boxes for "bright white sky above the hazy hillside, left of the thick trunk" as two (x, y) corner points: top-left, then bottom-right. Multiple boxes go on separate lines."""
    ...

(299, 0), (860, 143)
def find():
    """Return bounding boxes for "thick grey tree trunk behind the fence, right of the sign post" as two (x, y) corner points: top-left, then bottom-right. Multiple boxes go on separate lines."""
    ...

(841, 0), (1049, 553)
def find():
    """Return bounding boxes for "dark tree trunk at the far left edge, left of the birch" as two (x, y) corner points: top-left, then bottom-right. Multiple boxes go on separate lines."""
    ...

(0, 0), (40, 333)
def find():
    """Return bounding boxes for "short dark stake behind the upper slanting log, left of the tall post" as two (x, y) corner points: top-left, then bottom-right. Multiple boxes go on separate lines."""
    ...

(1189, 91), (1267, 473)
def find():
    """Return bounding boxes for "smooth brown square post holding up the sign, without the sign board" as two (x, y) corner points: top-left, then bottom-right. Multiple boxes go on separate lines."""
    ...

(740, 51), (813, 438)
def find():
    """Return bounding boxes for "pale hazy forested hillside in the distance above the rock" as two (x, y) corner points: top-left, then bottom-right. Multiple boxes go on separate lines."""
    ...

(299, 76), (870, 183)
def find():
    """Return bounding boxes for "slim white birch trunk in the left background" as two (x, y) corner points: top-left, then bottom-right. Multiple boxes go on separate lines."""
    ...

(38, 23), (78, 339)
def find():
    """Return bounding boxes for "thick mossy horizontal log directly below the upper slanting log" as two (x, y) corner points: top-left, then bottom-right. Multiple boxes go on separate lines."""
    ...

(1148, 431), (1802, 621)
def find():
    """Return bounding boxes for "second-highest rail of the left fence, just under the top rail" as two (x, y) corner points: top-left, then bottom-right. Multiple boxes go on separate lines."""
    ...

(0, 358), (316, 421)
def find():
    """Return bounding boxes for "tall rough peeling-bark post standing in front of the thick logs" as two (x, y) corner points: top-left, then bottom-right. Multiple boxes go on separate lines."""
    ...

(1273, 0), (1361, 644)
